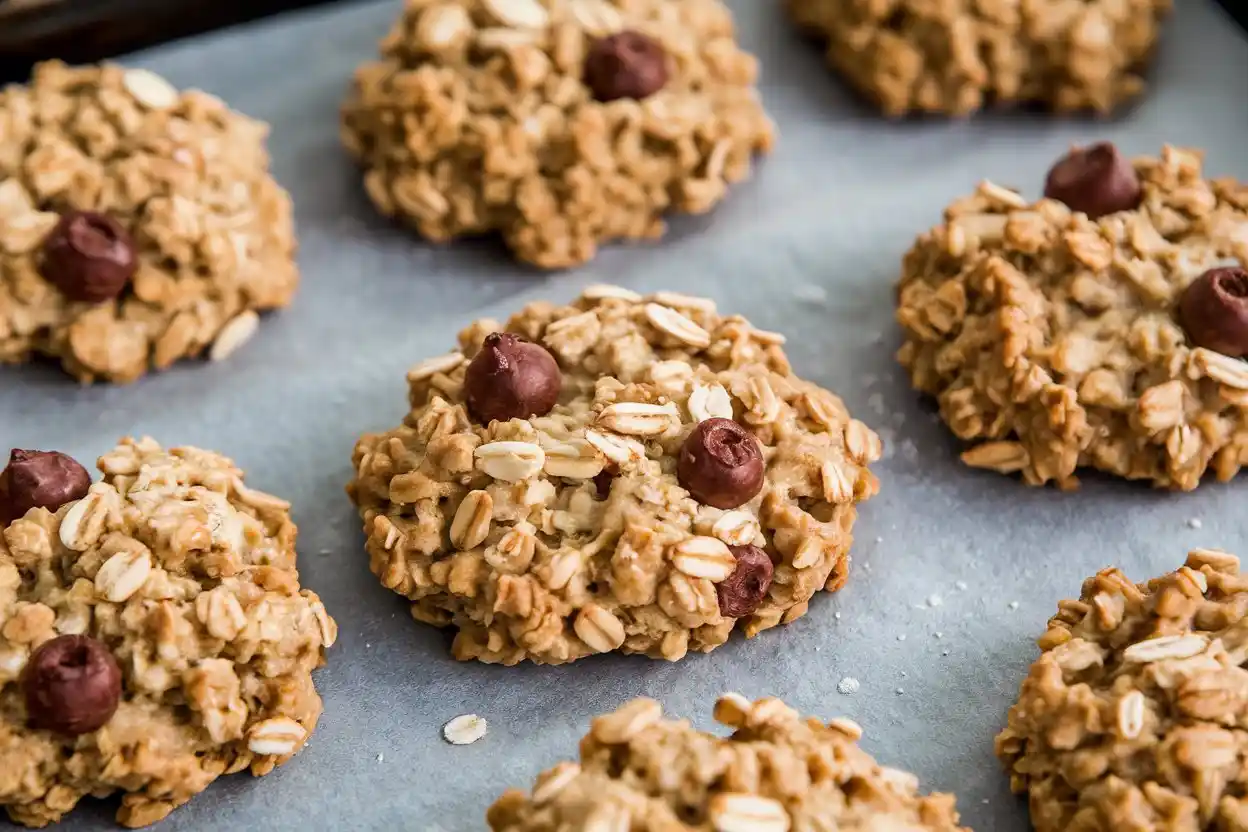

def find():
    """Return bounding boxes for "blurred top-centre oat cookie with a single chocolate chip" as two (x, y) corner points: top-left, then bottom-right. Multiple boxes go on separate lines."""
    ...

(342, 0), (773, 268)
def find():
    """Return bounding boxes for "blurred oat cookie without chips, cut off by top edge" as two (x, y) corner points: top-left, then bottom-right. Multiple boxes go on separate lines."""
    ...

(786, 0), (1171, 116)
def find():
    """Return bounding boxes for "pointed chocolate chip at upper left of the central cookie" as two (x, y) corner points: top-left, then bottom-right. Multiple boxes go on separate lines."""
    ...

(464, 332), (563, 424)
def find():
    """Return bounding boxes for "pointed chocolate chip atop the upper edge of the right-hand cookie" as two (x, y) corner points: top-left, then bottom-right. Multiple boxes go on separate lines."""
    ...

(1045, 141), (1139, 220)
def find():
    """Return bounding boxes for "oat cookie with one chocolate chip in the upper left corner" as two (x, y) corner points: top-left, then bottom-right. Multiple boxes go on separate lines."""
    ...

(0, 62), (298, 382)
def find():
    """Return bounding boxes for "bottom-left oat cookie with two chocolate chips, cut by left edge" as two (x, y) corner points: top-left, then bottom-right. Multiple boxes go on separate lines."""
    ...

(0, 439), (337, 827)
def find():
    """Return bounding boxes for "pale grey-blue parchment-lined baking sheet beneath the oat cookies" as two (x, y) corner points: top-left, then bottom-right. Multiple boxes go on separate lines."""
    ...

(7, 0), (1248, 832)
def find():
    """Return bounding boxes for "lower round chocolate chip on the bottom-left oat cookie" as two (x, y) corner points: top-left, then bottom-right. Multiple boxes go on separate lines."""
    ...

(21, 636), (121, 736)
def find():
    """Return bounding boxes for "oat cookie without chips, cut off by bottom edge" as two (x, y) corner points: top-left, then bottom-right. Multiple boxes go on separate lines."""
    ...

(487, 694), (966, 832)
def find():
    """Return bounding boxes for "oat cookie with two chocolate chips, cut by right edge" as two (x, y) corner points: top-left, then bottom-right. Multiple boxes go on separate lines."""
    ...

(897, 143), (1248, 490)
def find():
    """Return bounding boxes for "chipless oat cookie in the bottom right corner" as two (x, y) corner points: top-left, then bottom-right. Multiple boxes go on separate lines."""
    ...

(996, 549), (1248, 832)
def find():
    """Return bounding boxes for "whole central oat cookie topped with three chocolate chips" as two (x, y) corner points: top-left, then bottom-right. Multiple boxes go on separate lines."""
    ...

(347, 286), (880, 665)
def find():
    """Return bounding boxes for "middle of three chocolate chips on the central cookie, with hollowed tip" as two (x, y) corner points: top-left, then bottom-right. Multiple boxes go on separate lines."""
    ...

(676, 419), (763, 509)
